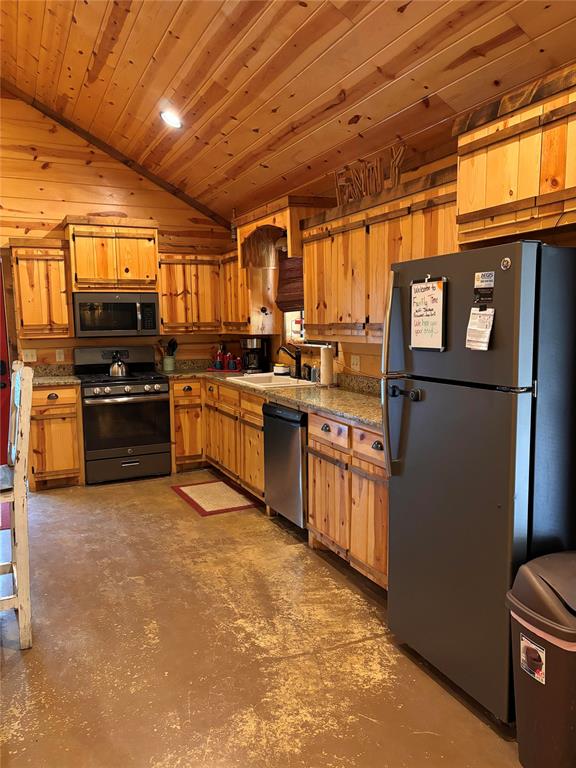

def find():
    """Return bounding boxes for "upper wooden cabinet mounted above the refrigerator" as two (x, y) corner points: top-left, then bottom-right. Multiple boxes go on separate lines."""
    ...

(455, 85), (576, 244)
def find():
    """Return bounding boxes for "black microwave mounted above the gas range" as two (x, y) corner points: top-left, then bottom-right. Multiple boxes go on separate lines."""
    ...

(73, 293), (160, 337)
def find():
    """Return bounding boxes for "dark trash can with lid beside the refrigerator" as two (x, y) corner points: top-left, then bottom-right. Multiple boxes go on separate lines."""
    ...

(506, 552), (576, 768)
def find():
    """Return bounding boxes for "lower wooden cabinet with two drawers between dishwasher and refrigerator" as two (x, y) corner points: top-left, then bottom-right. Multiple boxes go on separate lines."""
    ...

(308, 414), (388, 587)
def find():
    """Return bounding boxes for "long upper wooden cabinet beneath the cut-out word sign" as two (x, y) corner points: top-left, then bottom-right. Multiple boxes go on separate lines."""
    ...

(302, 159), (458, 339)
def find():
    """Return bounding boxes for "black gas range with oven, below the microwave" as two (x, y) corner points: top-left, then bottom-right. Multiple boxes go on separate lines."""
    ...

(74, 347), (171, 484)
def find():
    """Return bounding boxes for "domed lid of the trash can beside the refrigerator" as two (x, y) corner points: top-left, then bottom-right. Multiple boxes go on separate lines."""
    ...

(506, 552), (576, 642)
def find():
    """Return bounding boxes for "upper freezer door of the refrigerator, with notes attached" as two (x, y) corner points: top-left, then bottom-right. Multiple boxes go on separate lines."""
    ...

(390, 242), (540, 387)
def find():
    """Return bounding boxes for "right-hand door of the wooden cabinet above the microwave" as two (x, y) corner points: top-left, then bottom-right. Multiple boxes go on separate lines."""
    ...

(116, 229), (158, 290)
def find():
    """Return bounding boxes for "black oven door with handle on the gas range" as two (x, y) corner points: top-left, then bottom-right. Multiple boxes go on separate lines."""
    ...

(82, 393), (170, 461)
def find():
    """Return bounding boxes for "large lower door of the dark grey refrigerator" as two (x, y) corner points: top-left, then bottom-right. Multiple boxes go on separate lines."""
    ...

(388, 380), (531, 721)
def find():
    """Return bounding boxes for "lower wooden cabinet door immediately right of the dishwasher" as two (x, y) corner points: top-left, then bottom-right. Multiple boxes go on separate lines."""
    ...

(308, 447), (350, 551)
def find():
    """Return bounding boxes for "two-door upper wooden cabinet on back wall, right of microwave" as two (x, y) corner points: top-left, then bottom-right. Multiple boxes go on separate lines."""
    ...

(159, 254), (221, 334)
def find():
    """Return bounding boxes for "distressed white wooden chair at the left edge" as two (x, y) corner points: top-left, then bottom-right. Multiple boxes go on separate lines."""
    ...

(0, 361), (34, 649)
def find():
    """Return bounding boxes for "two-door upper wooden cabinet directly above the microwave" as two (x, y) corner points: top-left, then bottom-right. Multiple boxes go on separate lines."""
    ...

(66, 218), (158, 291)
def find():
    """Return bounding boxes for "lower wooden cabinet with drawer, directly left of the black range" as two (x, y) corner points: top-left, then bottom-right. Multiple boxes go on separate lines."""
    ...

(28, 387), (83, 491)
